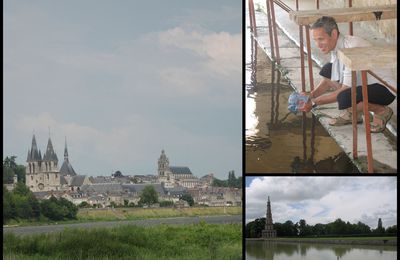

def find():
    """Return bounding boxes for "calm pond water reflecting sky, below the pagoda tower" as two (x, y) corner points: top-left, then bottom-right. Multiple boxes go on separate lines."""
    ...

(246, 241), (397, 260)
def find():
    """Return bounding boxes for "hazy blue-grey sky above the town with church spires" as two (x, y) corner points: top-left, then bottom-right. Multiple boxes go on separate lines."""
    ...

(3, 0), (242, 178)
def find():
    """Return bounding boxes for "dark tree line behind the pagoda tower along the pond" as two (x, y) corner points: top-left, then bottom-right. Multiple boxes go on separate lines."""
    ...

(246, 218), (397, 238)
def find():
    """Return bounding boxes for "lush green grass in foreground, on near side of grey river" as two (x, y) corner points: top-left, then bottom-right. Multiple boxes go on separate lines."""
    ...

(3, 222), (242, 260)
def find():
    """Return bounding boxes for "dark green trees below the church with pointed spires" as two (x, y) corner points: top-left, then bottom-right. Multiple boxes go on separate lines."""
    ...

(3, 182), (78, 225)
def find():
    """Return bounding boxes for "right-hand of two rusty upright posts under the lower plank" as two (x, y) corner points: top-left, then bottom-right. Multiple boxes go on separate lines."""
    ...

(361, 70), (374, 173)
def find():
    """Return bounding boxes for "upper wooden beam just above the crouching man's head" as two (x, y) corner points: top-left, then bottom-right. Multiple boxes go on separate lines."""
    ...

(289, 4), (397, 25)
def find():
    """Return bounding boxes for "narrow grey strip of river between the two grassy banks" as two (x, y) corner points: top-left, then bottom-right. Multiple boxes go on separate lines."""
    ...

(3, 215), (242, 235)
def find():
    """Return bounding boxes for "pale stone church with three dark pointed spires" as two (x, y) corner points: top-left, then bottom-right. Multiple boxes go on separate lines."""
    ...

(26, 135), (86, 192)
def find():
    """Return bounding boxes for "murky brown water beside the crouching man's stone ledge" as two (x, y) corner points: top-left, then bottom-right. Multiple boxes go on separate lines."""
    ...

(245, 32), (358, 174)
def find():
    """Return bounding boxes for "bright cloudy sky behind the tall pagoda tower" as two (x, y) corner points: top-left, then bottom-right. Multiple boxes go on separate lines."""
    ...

(246, 177), (397, 228)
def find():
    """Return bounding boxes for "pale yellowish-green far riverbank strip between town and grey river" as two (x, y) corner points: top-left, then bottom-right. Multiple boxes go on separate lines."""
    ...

(4, 207), (242, 226)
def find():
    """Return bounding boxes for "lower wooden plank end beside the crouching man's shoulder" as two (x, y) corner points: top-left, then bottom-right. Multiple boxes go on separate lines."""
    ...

(338, 46), (397, 71)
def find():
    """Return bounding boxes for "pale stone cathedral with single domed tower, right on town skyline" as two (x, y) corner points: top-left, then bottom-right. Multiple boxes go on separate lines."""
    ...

(158, 150), (200, 188)
